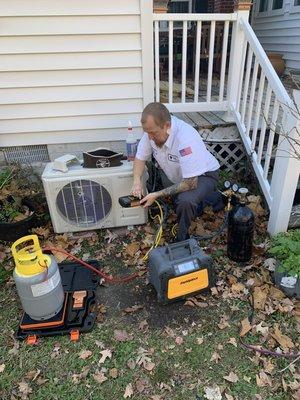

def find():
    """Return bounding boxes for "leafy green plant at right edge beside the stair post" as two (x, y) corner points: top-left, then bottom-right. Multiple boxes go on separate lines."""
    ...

(269, 229), (300, 277)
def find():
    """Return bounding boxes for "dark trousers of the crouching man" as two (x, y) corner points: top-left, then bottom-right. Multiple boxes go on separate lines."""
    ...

(161, 170), (219, 241)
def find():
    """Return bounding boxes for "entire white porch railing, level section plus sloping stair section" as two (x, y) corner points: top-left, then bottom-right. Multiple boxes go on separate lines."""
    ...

(153, 11), (300, 234)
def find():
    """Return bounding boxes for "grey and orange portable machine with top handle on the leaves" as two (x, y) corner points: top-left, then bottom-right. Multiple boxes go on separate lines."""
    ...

(148, 239), (215, 304)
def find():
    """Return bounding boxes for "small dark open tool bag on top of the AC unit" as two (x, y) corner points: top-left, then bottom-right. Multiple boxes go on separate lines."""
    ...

(83, 149), (123, 168)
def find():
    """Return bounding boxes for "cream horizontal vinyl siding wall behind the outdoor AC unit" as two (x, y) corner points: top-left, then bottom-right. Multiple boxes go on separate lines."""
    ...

(0, 0), (153, 147)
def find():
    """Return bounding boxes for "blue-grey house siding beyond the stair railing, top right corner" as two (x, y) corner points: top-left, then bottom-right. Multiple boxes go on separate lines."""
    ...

(252, 0), (300, 71)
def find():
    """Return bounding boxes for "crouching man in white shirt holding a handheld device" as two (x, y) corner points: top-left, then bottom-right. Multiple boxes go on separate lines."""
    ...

(132, 103), (220, 241)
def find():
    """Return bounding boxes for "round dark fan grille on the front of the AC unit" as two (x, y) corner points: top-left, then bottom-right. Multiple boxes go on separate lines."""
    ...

(56, 179), (112, 227)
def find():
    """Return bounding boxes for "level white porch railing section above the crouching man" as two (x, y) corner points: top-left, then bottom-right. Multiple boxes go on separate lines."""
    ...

(153, 14), (237, 112)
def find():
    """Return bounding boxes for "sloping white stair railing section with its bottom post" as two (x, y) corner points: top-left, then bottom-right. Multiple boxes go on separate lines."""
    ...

(230, 18), (300, 234)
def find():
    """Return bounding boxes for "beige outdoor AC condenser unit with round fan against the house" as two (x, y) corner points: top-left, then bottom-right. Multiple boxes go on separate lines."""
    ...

(42, 161), (147, 233)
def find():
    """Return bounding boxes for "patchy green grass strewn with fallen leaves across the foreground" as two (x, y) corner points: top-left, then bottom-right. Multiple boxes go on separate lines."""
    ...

(0, 287), (291, 400)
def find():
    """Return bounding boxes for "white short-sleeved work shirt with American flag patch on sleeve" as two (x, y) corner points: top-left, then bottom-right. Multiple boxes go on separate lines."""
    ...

(136, 117), (220, 183)
